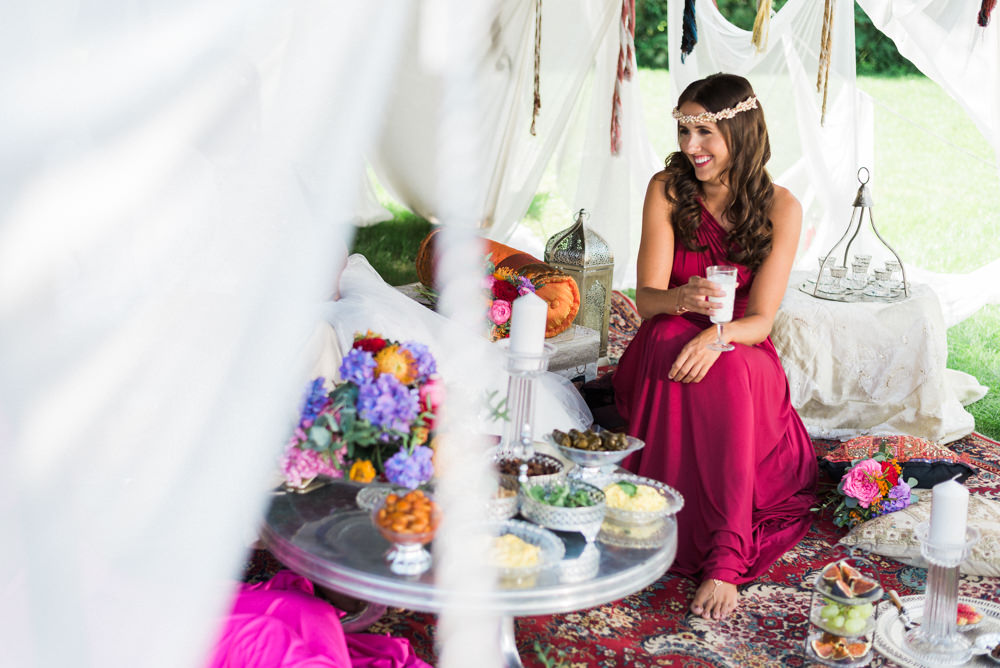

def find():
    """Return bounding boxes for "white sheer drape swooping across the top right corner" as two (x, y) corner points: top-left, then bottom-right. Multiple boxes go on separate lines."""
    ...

(858, 0), (1000, 169)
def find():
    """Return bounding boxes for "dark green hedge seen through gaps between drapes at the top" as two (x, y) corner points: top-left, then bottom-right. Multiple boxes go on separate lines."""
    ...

(635, 0), (918, 76)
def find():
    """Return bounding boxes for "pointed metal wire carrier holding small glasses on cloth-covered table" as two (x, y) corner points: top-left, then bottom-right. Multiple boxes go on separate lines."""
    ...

(799, 167), (910, 302)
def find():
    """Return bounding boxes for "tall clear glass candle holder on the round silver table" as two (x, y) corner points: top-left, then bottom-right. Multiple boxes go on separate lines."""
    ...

(497, 341), (556, 464)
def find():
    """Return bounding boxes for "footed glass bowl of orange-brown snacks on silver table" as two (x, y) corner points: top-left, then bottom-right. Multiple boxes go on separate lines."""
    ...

(372, 489), (441, 575)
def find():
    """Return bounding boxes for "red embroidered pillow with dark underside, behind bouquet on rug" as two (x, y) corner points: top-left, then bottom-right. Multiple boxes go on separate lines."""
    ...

(819, 436), (976, 489)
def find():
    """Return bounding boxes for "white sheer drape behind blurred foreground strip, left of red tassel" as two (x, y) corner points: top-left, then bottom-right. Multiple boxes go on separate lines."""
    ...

(372, 0), (621, 235)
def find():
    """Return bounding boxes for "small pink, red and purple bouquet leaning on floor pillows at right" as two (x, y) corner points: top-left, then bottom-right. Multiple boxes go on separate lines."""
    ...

(823, 446), (917, 529)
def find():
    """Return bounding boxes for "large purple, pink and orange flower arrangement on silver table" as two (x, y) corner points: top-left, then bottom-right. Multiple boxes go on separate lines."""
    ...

(281, 331), (444, 490)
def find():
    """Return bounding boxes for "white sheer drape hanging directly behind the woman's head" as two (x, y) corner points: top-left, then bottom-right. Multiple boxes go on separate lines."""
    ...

(668, 0), (875, 269)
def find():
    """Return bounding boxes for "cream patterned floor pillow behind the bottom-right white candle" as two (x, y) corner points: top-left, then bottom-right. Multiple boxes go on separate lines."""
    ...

(840, 490), (1000, 577)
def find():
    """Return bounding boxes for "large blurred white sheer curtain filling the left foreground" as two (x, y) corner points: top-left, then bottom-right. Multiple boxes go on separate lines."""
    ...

(0, 0), (410, 668)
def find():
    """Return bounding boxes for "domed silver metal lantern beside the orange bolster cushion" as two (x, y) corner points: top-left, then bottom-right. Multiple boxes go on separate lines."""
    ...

(545, 209), (615, 357)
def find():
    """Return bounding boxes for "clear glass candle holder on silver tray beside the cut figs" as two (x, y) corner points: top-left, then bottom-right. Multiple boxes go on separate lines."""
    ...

(903, 522), (979, 666)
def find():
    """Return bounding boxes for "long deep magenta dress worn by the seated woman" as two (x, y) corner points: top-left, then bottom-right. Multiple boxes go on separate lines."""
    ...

(613, 209), (818, 584)
